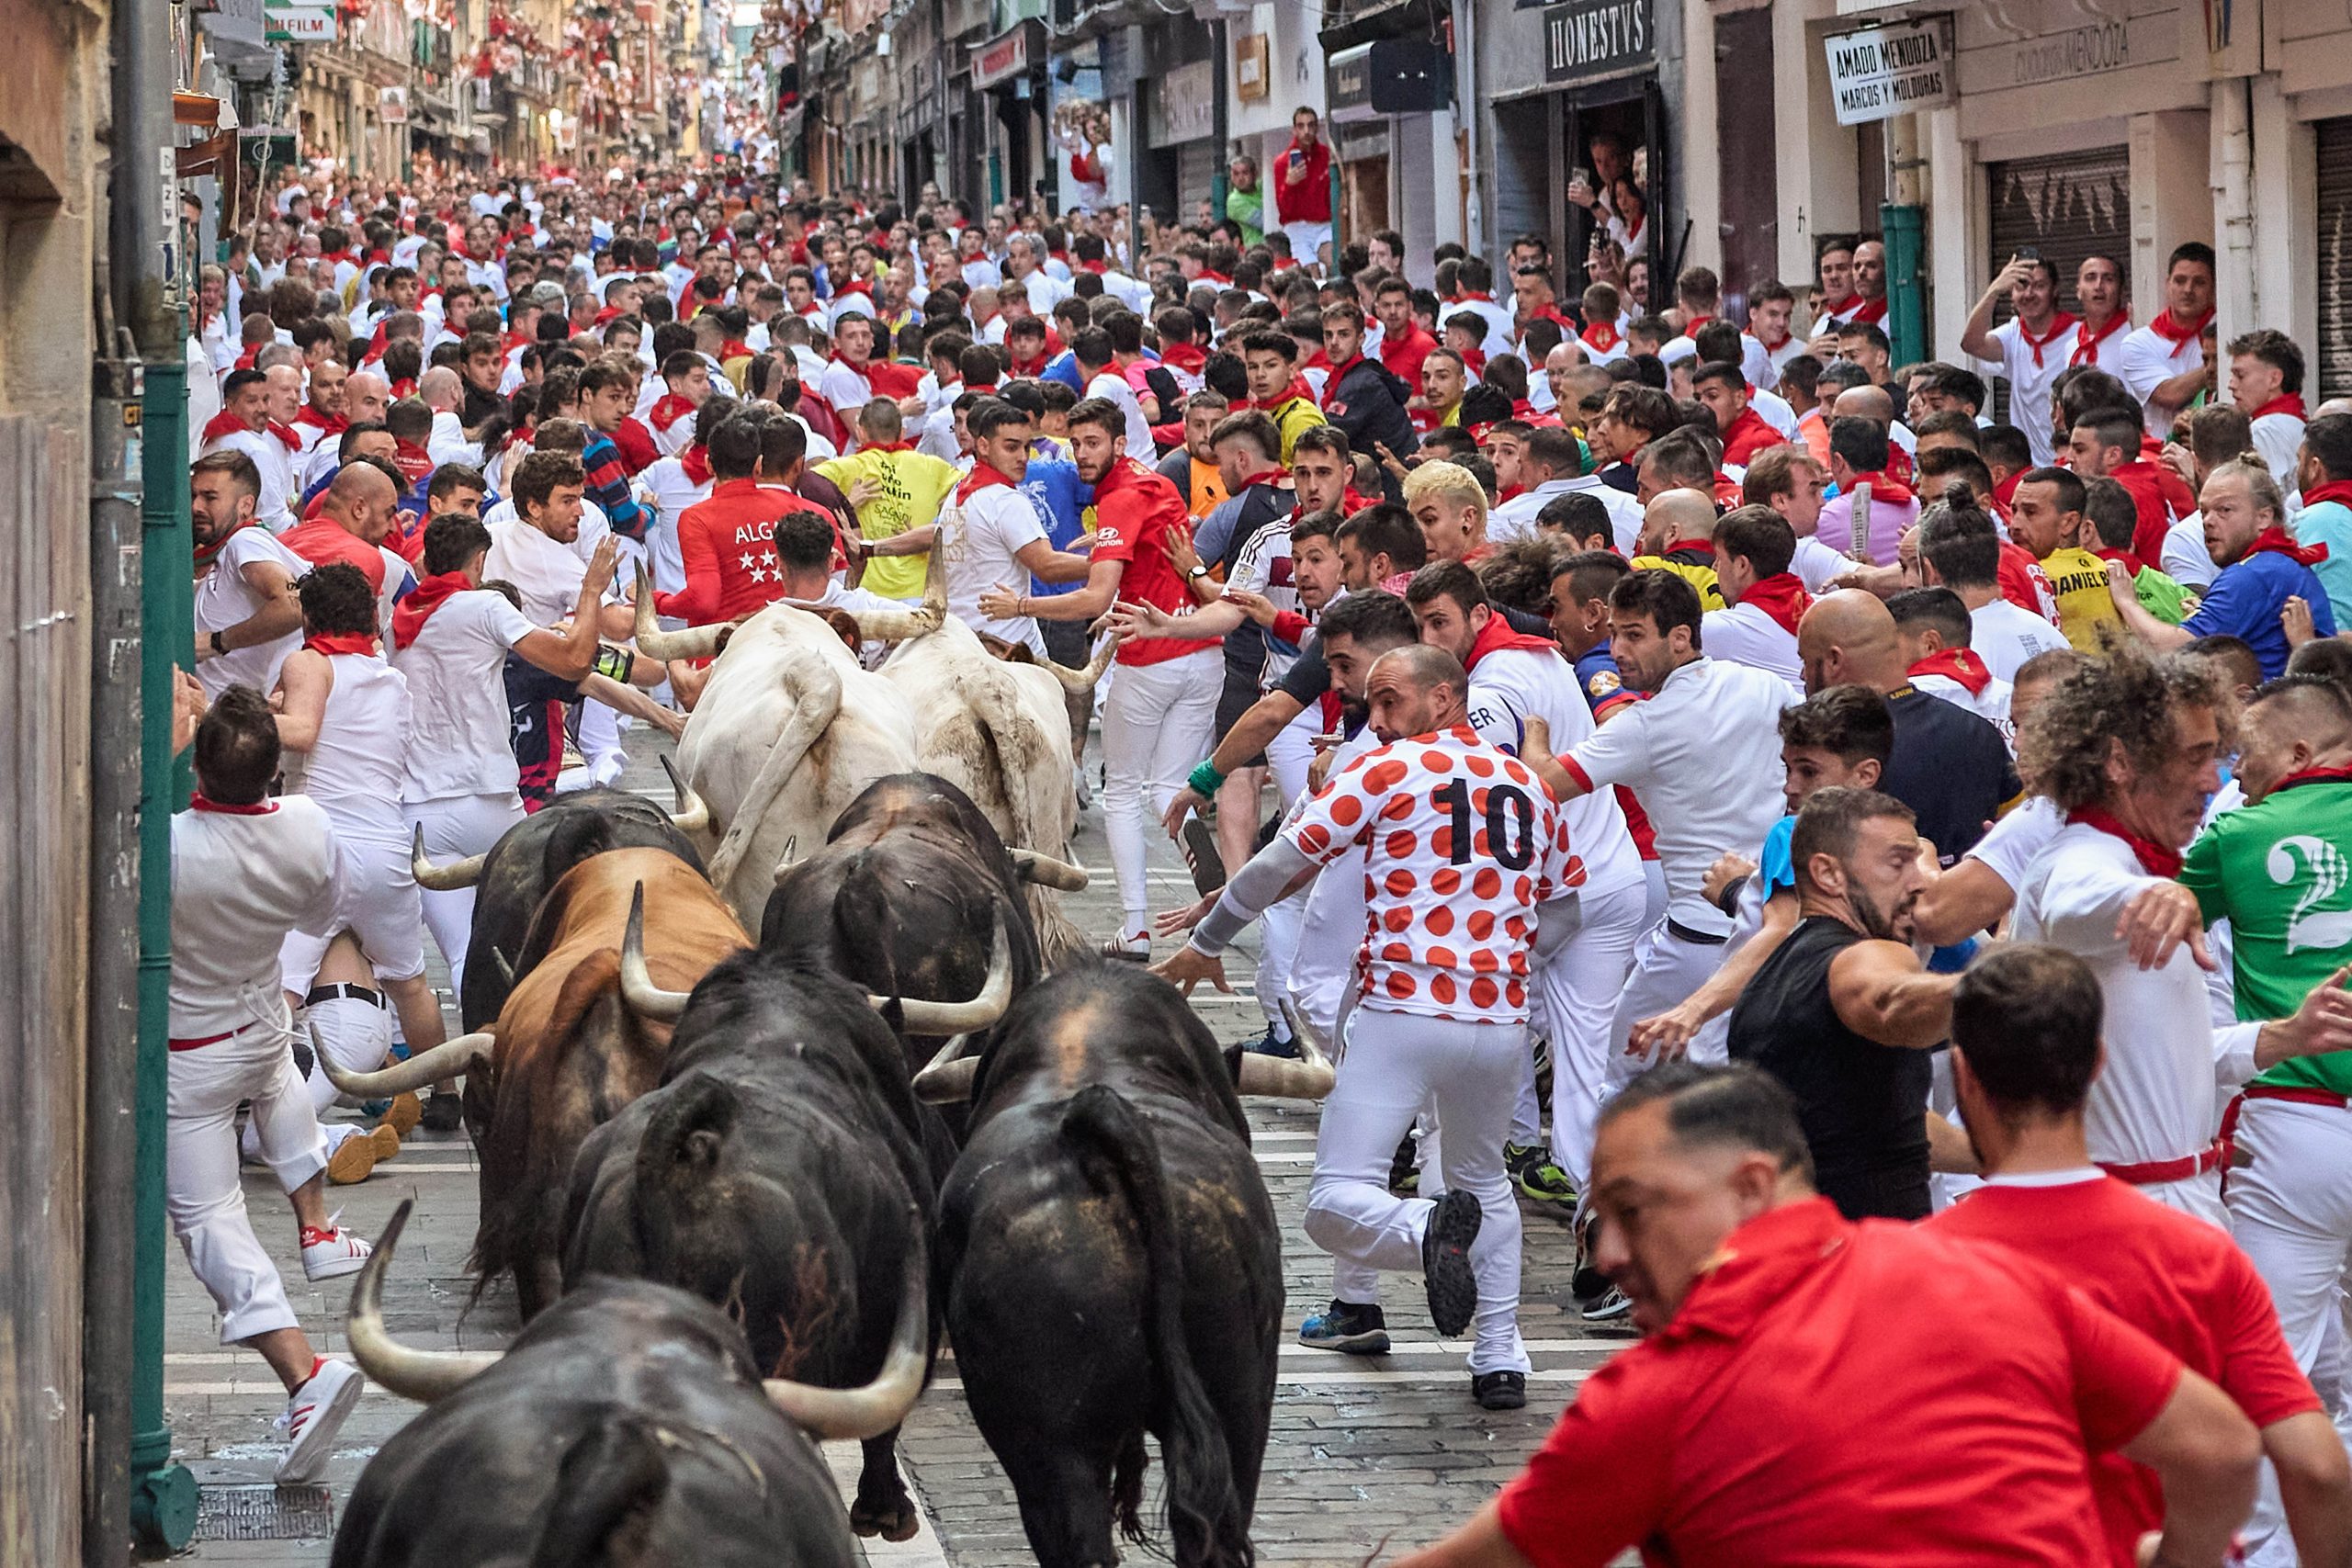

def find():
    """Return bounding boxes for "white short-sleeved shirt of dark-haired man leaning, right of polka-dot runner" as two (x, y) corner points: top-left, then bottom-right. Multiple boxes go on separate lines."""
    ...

(1559, 659), (1790, 936)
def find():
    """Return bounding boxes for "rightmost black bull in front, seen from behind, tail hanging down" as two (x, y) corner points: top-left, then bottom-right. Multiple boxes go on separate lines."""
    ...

(917, 964), (1329, 1568)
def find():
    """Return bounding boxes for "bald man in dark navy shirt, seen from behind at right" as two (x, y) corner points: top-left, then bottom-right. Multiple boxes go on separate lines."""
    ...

(1797, 588), (2023, 865)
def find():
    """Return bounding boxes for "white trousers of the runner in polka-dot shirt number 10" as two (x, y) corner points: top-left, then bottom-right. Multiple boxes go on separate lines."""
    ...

(1306, 1001), (1529, 1373)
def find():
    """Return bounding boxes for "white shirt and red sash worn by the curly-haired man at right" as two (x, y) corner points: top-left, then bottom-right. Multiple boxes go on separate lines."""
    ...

(2013, 813), (2227, 1229)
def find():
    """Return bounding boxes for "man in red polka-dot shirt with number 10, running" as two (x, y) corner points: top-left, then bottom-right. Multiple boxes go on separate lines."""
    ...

(1152, 644), (1585, 1411)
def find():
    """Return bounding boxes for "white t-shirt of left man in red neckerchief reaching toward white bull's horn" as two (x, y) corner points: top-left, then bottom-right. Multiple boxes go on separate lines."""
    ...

(393, 590), (538, 807)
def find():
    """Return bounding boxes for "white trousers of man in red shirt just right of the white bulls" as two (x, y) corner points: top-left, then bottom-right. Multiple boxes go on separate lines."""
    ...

(1103, 647), (1226, 938)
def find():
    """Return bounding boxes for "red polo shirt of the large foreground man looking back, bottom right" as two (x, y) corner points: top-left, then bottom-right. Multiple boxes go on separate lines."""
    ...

(1500, 1199), (2180, 1568)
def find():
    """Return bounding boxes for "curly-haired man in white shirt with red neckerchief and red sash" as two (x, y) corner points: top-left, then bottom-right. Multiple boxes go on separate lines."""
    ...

(2011, 644), (2230, 1229)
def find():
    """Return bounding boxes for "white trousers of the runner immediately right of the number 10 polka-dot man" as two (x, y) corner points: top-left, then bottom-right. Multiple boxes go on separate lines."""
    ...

(1510, 882), (1649, 1192)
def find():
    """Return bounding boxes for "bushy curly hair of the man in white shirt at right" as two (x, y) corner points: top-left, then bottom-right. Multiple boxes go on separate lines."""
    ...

(2018, 642), (2237, 811)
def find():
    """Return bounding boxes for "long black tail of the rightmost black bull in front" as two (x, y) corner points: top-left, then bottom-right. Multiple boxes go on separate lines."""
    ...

(1061, 1084), (1256, 1568)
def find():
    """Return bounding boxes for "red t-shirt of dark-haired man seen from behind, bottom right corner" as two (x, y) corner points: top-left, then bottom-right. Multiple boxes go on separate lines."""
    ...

(1927, 1173), (2322, 1568)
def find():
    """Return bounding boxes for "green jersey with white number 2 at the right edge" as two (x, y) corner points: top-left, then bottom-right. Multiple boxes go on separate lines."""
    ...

(2180, 776), (2352, 1096)
